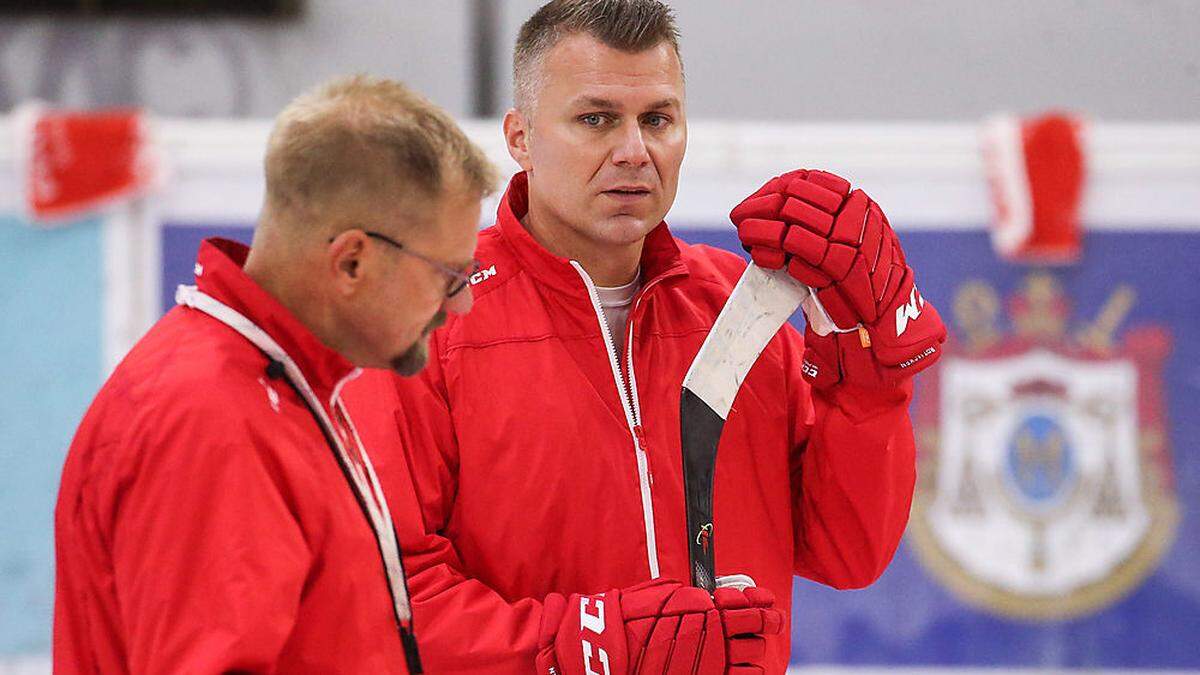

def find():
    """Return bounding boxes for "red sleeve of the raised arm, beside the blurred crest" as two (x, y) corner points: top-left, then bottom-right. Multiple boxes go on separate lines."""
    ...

(785, 330), (916, 589)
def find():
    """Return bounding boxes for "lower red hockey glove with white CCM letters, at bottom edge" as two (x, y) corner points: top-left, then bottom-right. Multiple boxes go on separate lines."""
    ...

(538, 579), (782, 675)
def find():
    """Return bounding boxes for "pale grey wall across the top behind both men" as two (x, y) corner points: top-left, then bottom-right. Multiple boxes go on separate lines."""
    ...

(0, 0), (1200, 121)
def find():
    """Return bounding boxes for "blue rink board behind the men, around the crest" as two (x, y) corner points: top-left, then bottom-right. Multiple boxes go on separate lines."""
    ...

(162, 223), (1200, 669)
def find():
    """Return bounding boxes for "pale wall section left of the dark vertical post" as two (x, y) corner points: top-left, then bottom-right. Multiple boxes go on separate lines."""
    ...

(0, 0), (470, 118)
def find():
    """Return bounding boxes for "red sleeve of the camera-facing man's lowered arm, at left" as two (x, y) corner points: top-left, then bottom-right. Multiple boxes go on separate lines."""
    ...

(348, 333), (542, 673)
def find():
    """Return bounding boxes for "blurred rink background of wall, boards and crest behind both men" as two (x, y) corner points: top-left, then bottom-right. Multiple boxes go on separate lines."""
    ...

(0, 0), (1200, 675)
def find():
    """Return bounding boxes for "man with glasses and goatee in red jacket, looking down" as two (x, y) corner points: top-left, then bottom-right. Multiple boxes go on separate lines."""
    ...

(54, 77), (493, 674)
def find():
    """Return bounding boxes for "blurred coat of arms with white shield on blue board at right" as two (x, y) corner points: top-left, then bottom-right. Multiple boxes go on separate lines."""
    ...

(910, 273), (1178, 620)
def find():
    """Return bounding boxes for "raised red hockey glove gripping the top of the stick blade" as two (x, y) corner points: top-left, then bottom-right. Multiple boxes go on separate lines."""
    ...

(730, 169), (946, 388)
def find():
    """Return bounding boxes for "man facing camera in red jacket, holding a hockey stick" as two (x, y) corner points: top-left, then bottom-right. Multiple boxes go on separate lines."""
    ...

(348, 0), (944, 674)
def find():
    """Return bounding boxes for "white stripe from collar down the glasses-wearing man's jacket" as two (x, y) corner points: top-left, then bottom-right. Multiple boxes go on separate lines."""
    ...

(175, 286), (413, 622)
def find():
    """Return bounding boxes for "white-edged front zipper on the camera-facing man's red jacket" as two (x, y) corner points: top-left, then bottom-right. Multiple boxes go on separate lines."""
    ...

(571, 261), (659, 579)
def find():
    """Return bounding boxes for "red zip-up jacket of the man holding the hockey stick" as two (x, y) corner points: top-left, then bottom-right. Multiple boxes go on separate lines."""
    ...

(347, 174), (914, 673)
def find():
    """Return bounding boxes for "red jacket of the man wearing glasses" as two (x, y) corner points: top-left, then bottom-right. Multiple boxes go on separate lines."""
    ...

(54, 240), (412, 675)
